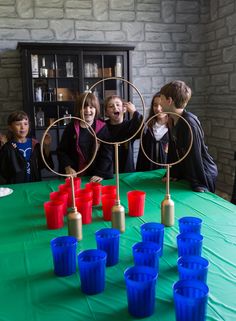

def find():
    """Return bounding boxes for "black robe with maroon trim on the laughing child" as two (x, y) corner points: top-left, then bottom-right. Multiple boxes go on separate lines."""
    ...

(57, 120), (113, 179)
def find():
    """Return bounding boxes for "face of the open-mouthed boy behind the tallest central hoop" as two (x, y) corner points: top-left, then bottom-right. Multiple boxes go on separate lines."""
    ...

(106, 98), (125, 125)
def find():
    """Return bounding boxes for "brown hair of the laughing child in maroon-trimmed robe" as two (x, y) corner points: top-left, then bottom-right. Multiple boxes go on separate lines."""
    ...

(75, 93), (100, 119)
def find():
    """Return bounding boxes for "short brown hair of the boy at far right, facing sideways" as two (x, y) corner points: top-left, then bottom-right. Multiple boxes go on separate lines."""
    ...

(160, 80), (192, 109)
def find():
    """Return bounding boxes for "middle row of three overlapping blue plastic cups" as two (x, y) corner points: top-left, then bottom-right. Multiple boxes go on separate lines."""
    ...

(124, 222), (164, 318)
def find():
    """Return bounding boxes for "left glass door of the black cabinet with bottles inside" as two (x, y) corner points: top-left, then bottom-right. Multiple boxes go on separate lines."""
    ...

(31, 54), (79, 128)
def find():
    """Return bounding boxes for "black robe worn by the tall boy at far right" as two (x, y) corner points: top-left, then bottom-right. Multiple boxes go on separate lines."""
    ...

(168, 110), (218, 193)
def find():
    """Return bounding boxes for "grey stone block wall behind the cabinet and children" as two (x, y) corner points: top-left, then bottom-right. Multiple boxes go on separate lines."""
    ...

(0, 0), (236, 193)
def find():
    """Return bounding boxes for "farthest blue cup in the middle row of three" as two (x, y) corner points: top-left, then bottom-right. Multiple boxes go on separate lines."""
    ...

(140, 222), (165, 256)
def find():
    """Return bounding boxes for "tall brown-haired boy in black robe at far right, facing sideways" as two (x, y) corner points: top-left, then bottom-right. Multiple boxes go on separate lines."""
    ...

(160, 80), (218, 193)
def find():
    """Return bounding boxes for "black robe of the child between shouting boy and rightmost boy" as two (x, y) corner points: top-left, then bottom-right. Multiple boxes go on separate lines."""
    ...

(136, 128), (169, 172)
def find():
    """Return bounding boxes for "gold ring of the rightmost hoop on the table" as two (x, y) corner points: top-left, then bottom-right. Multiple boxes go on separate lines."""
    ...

(140, 111), (193, 167)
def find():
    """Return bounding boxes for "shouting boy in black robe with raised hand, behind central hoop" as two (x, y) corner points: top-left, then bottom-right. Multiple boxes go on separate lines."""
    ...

(105, 95), (143, 173)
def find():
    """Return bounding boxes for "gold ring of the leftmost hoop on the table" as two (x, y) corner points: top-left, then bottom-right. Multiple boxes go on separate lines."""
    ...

(40, 116), (98, 177)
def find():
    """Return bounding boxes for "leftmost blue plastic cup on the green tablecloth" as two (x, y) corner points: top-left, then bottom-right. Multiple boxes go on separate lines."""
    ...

(50, 236), (77, 276)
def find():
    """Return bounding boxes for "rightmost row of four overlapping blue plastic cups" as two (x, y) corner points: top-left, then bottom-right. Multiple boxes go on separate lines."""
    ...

(173, 217), (209, 321)
